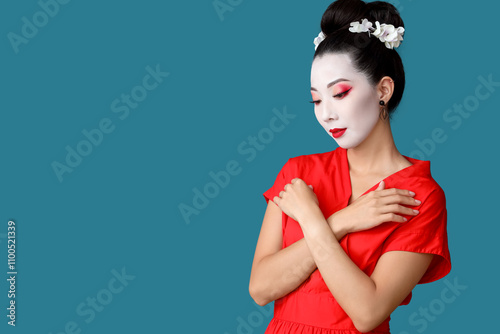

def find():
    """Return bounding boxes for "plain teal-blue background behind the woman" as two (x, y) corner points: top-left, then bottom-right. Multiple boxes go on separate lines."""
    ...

(0, 0), (500, 334)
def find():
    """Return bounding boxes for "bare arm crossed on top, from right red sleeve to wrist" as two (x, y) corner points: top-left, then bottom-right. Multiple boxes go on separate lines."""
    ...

(301, 214), (433, 332)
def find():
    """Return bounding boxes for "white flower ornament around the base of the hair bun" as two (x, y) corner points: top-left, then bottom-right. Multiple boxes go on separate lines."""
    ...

(314, 19), (405, 50)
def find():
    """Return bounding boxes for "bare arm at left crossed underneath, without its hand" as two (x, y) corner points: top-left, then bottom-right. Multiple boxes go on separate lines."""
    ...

(249, 201), (347, 306)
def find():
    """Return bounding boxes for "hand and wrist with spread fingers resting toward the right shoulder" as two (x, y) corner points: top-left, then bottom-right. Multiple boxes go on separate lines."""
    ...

(327, 181), (420, 237)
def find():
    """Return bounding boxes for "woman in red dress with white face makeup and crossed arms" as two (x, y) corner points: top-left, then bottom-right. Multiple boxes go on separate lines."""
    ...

(249, 0), (451, 334)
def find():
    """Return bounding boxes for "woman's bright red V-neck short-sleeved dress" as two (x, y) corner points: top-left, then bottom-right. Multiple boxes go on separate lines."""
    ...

(263, 147), (451, 334)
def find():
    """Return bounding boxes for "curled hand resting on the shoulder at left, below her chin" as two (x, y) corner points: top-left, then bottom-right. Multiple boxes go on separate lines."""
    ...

(273, 178), (321, 223)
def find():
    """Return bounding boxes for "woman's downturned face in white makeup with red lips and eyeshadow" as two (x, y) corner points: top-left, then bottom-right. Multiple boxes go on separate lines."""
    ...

(311, 54), (380, 149)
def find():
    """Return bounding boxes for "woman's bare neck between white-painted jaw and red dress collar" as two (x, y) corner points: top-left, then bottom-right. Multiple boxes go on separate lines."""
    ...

(347, 119), (409, 175)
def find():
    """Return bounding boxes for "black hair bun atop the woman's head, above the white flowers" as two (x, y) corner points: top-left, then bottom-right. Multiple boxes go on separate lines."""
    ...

(321, 0), (404, 35)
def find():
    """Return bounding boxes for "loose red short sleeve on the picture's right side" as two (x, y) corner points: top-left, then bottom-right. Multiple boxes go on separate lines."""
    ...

(382, 186), (451, 284)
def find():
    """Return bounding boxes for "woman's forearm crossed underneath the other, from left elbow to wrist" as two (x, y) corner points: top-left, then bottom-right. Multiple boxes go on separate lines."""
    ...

(251, 217), (346, 305)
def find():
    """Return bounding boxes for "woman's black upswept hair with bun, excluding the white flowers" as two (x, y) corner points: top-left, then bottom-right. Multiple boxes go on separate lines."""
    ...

(313, 0), (405, 117)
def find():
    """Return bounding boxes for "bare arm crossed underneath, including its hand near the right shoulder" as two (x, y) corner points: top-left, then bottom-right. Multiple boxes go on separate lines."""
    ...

(249, 181), (416, 305)
